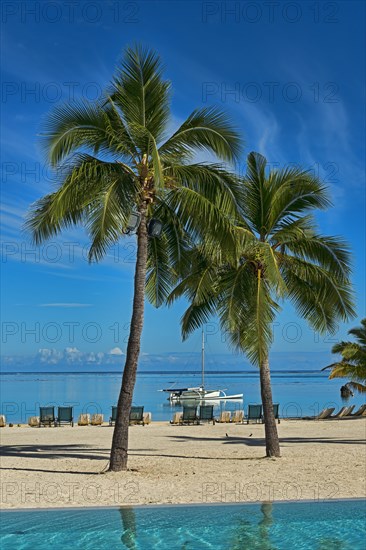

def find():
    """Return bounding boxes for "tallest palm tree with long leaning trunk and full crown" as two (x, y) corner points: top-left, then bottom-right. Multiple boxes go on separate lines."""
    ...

(26, 46), (241, 471)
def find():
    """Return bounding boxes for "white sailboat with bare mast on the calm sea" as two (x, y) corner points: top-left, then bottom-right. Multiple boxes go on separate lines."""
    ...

(160, 331), (243, 403)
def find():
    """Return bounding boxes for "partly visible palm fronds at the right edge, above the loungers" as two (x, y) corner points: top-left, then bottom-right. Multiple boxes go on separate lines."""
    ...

(322, 319), (366, 393)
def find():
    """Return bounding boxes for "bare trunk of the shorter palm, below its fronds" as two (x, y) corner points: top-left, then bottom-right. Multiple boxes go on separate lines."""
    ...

(259, 356), (281, 457)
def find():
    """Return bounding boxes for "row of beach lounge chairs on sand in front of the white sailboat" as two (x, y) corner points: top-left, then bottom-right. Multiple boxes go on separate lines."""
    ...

(170, 403), (280, 425)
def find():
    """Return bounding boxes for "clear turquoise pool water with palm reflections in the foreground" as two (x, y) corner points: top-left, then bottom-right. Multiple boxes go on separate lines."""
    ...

(1, 499), (366, 550)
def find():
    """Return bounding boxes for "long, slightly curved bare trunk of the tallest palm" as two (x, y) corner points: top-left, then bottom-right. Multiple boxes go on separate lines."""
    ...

(109, 203), (148, 472)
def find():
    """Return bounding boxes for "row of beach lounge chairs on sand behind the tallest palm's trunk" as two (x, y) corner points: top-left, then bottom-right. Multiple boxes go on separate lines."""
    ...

(32, 407), (150, 427)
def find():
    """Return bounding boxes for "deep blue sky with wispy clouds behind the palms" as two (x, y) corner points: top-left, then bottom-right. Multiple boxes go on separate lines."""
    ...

(1, 0), (365, 366)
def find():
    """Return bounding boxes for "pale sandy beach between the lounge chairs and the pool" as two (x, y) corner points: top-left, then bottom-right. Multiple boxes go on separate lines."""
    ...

(0, 418), (366, 508)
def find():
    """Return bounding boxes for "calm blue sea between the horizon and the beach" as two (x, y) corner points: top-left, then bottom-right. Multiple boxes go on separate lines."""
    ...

(0, 369), (364, 423)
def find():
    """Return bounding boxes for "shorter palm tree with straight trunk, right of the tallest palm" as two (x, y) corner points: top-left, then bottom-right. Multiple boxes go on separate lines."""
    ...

(169, 153), (354, 457)
